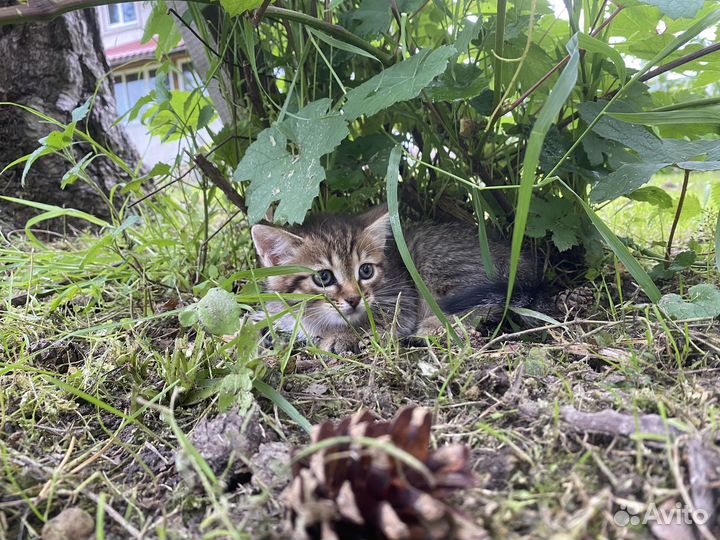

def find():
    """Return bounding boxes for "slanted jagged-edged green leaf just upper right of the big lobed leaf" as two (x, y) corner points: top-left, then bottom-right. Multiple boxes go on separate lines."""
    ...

(343, 46), (456, 122)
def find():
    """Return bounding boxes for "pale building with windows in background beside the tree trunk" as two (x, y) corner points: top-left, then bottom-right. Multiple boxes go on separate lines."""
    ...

(96, 2), (195, 166)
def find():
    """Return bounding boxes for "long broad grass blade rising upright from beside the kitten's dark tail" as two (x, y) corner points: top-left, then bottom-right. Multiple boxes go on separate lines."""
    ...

(506, 34), (580, 306)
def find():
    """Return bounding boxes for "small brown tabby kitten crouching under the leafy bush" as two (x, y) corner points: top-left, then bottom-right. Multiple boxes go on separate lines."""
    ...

(252, 207), (539, 353)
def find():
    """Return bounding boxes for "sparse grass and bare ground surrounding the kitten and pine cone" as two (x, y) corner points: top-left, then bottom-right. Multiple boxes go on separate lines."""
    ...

(0, 175), (720, 539)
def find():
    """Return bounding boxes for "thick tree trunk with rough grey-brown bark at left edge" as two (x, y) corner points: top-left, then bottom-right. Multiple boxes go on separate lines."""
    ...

(0, 0), (137, 230)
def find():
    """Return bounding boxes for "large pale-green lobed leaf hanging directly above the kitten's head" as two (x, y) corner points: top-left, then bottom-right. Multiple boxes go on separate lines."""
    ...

(233, 99), (349, 223)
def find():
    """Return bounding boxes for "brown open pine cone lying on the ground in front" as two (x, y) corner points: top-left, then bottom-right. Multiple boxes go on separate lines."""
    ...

(283, 407), (487, 540)
